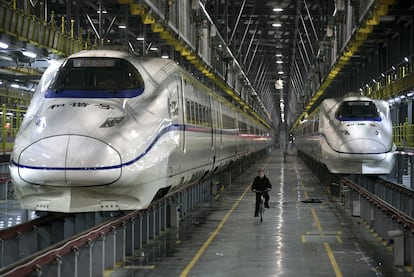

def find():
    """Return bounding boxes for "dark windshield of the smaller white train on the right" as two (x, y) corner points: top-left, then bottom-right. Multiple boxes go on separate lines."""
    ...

(335, 101), (381, 121)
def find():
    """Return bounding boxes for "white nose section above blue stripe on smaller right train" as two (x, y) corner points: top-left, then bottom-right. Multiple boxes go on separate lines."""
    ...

(339, 139), (389, 154)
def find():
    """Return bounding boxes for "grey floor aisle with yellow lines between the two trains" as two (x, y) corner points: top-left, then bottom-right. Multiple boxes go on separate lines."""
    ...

(105, 151), (413, 277)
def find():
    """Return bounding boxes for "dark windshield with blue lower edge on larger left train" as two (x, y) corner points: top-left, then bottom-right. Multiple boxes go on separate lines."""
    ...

(46, 58), (144, 98)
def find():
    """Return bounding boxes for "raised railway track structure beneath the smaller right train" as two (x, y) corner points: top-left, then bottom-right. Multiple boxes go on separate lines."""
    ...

(302, 152), (414, 267)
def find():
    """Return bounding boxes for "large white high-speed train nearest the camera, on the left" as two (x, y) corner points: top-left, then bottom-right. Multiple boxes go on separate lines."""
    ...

(10, 50), (272, 213)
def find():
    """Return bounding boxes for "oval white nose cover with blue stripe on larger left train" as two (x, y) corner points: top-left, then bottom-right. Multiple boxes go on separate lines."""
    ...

(18, 135), (121, 186)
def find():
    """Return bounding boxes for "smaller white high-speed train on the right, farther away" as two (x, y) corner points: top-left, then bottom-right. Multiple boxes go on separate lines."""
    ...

(293, 95), (396, 175)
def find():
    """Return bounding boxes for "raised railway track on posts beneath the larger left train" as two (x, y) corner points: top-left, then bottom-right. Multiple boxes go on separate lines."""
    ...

(0, 180), (212, 276)
